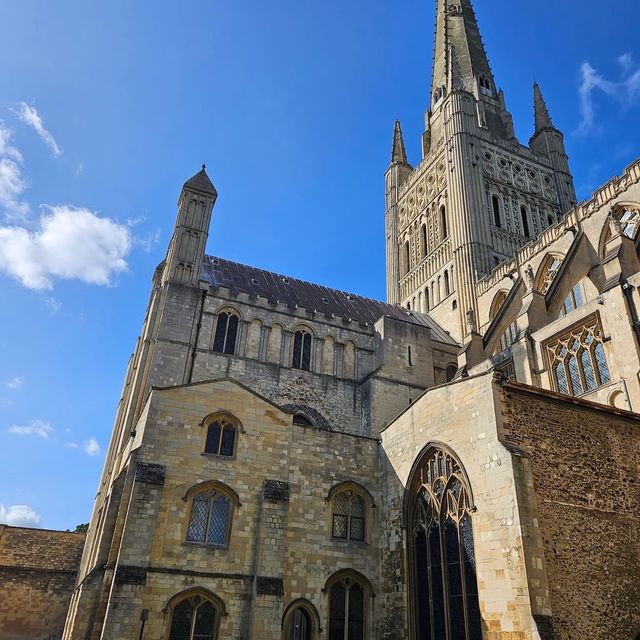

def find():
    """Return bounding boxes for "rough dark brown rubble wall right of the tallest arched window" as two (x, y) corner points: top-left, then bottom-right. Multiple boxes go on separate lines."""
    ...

(503, 384), (640, 640)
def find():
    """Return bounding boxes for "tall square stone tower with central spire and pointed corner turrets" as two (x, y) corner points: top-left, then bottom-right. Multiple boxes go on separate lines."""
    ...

(386, 0), (576, 340)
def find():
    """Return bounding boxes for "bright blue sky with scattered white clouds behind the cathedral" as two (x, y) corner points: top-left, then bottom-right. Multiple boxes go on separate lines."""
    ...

(0, 0), (640, 529)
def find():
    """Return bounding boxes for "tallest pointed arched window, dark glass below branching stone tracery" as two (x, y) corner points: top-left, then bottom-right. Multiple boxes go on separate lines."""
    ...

(405, 447), (482, 640)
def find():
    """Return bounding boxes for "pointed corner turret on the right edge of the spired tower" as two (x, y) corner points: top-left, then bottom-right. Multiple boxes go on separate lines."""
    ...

(529, 82), (576, 214)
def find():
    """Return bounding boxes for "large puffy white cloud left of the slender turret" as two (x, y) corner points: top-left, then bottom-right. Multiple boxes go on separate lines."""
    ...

(0, 205), (132, 289)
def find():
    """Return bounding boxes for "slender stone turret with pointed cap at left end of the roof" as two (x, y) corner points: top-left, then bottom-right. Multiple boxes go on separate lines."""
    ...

(162, 165), (218, 285)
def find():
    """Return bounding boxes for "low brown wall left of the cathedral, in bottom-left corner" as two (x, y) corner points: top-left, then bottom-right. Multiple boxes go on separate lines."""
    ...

(0, 525), (85, 640)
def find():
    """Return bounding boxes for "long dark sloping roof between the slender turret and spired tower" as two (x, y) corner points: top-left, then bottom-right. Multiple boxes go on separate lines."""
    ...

(202, 256), (458, 346)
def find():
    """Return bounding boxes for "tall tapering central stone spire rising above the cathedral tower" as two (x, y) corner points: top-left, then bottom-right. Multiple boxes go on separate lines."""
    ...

(431, 0), (495, 106)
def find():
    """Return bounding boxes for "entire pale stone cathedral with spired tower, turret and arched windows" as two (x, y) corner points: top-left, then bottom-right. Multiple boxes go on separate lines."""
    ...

(63, 0), (640, 640)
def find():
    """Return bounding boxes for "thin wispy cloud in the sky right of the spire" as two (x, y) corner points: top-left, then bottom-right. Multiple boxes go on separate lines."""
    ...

(577, 53), (640, 135)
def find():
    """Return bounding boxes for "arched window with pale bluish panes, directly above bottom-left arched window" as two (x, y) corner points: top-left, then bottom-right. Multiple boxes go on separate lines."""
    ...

(187, 484), (233, 547)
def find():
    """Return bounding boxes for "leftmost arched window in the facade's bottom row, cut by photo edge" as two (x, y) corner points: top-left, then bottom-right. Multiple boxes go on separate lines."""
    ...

(169, 590), (223, 640)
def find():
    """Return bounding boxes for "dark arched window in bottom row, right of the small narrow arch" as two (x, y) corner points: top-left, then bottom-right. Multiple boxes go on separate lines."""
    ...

(326, 571), (371, 640)
